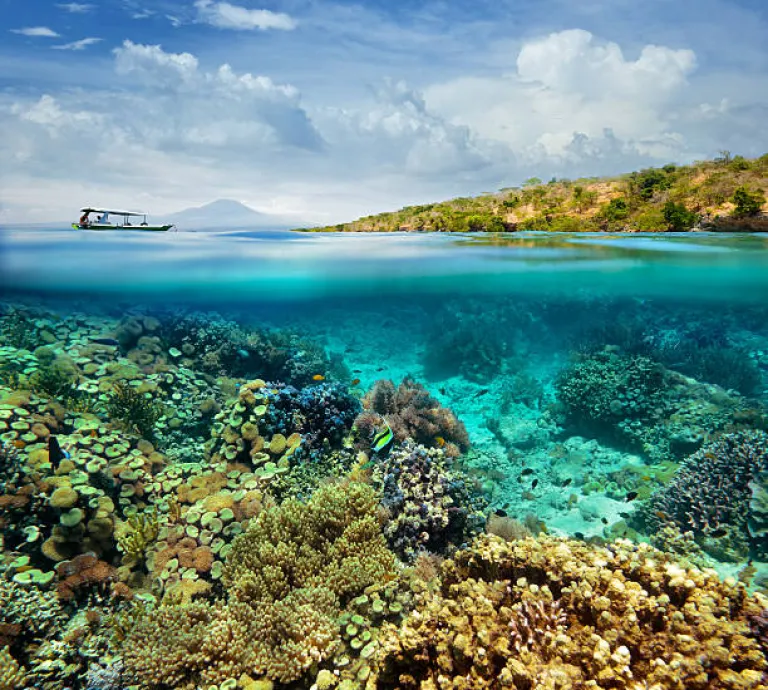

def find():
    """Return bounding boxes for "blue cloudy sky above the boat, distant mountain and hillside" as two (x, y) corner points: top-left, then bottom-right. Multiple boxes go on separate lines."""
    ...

(0, 0), (768, 224)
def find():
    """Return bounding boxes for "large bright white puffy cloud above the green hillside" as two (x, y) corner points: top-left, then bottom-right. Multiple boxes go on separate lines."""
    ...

(427, 29), (696, 167)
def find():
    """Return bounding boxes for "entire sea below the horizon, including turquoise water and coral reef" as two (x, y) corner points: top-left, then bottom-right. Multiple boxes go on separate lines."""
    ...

(0, 229), (768, 690)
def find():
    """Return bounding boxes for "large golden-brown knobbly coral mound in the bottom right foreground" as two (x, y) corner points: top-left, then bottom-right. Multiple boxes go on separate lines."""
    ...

(366, 536), (768, 690)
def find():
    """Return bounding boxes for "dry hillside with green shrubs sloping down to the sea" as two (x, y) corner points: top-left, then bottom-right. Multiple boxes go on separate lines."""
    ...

(305, 153), (768, 232)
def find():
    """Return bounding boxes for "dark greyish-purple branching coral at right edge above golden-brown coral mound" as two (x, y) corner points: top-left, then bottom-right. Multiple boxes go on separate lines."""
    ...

(641, 431), (768, 556)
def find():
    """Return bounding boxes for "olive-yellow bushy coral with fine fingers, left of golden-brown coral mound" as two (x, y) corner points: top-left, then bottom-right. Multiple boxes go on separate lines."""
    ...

(123, 483), (395, 688)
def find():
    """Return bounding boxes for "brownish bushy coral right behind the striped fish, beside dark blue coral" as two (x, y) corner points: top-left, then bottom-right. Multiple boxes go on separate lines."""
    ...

(355, 378), (469, 456)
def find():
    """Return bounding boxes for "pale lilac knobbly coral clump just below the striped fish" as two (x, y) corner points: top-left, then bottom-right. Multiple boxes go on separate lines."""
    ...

(372, 443), (485, 561)
